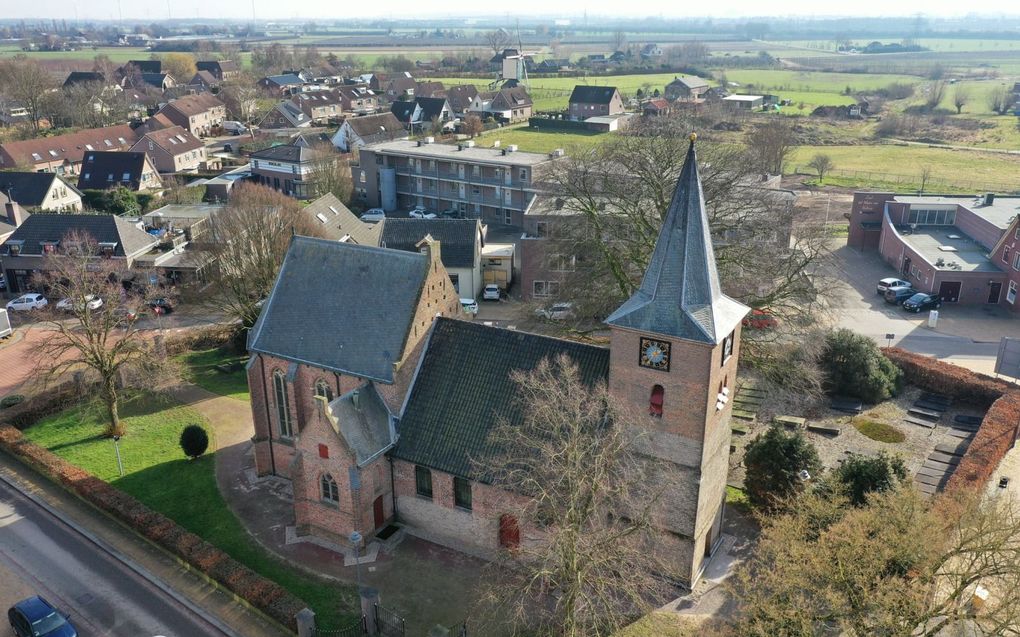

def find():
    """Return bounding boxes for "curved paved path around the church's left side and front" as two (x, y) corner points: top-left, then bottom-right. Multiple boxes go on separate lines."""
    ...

(174, 385), (489, 635)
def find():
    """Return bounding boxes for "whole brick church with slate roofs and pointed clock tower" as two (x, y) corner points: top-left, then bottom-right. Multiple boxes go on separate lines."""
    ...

(248, 138), (749, 585)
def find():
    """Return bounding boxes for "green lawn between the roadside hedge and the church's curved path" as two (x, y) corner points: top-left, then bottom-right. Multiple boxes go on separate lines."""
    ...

(24, 395), (354, 627)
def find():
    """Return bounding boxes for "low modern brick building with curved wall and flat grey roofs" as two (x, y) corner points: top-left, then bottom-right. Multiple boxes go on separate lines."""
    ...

(847, 193), (1020, 312)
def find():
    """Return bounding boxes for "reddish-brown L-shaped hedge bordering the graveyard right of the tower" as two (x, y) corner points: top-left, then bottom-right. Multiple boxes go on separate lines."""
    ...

(882, 348), (1020, 490)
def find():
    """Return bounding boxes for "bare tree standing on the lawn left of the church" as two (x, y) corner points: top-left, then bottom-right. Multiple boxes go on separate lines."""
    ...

(34, 231), (173, 435)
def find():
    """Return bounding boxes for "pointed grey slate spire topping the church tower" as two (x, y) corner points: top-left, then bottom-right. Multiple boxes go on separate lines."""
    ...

(606, 132), (748, 344)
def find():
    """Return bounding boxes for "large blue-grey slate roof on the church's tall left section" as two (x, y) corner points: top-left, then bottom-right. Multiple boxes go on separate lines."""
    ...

(248, 236), (428, 383)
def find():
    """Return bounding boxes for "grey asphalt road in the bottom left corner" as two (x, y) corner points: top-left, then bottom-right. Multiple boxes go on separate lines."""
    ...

(0, 481), (223, 637)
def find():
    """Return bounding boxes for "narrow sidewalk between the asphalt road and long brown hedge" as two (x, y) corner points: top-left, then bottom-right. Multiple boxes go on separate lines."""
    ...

(0, 454), (289, 637)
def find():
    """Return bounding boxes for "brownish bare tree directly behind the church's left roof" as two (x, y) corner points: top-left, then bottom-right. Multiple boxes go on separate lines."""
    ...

(197, 179), (321, 329)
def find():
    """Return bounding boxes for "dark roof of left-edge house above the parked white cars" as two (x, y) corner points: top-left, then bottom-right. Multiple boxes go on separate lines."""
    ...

(3, 212), (157, 257)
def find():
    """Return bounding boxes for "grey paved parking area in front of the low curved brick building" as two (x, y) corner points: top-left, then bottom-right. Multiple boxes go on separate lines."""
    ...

(826, 246), (1020, 373)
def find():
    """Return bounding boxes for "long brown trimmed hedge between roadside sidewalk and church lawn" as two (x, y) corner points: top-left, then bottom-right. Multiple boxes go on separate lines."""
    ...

(0, 425), (308, 631)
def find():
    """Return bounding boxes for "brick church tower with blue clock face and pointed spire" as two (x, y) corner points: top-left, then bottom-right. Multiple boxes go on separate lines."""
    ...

(606, 134), (749, 586)
